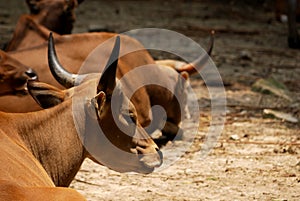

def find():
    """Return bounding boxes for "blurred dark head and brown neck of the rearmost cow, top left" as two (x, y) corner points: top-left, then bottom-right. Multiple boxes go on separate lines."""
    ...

(5, 0), (83, 51)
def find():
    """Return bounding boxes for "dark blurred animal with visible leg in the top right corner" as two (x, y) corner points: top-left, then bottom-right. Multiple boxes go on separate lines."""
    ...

(275, 0), (300, 49)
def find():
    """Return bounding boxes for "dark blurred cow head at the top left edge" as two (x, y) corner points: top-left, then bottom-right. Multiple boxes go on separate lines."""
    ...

(26, 0), (83, 34)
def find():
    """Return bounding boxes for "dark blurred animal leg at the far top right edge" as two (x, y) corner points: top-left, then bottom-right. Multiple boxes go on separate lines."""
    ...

(288, 0), (300, 48)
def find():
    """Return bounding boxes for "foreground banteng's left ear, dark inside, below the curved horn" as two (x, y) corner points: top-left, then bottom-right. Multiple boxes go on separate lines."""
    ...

(27, 81), (66, 109)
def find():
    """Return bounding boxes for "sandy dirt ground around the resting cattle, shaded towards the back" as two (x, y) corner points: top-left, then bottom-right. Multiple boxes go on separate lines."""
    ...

(0, 0), (300, 201)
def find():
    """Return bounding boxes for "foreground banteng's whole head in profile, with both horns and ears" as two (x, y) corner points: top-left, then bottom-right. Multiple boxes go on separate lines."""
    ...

(28, 33), (162, 173)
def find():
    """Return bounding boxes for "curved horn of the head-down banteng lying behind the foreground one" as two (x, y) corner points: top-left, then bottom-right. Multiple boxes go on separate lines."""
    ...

(176, 30), (215, 75)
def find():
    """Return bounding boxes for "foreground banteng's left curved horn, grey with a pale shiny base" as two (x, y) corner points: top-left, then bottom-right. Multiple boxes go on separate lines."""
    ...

(48, 32), (78, 88)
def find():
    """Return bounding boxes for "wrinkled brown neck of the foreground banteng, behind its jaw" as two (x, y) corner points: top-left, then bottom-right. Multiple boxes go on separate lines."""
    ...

(5, 100), (85, 186)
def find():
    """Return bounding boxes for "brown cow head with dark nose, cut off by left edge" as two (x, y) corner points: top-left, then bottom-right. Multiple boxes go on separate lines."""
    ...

(0, 50), (37, 95)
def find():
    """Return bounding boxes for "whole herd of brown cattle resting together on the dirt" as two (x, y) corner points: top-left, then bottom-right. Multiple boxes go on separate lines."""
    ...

(0, 0), (299, 201)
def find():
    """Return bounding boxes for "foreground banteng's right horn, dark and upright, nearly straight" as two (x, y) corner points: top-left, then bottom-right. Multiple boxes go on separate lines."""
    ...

(97, 36), (120, 95)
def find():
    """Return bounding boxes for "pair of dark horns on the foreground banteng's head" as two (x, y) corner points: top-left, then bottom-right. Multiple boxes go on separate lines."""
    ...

(48, 33), (120, 88)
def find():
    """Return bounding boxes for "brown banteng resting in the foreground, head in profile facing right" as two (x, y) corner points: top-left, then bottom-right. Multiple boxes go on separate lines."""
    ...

(0, 35), (162, 200)
